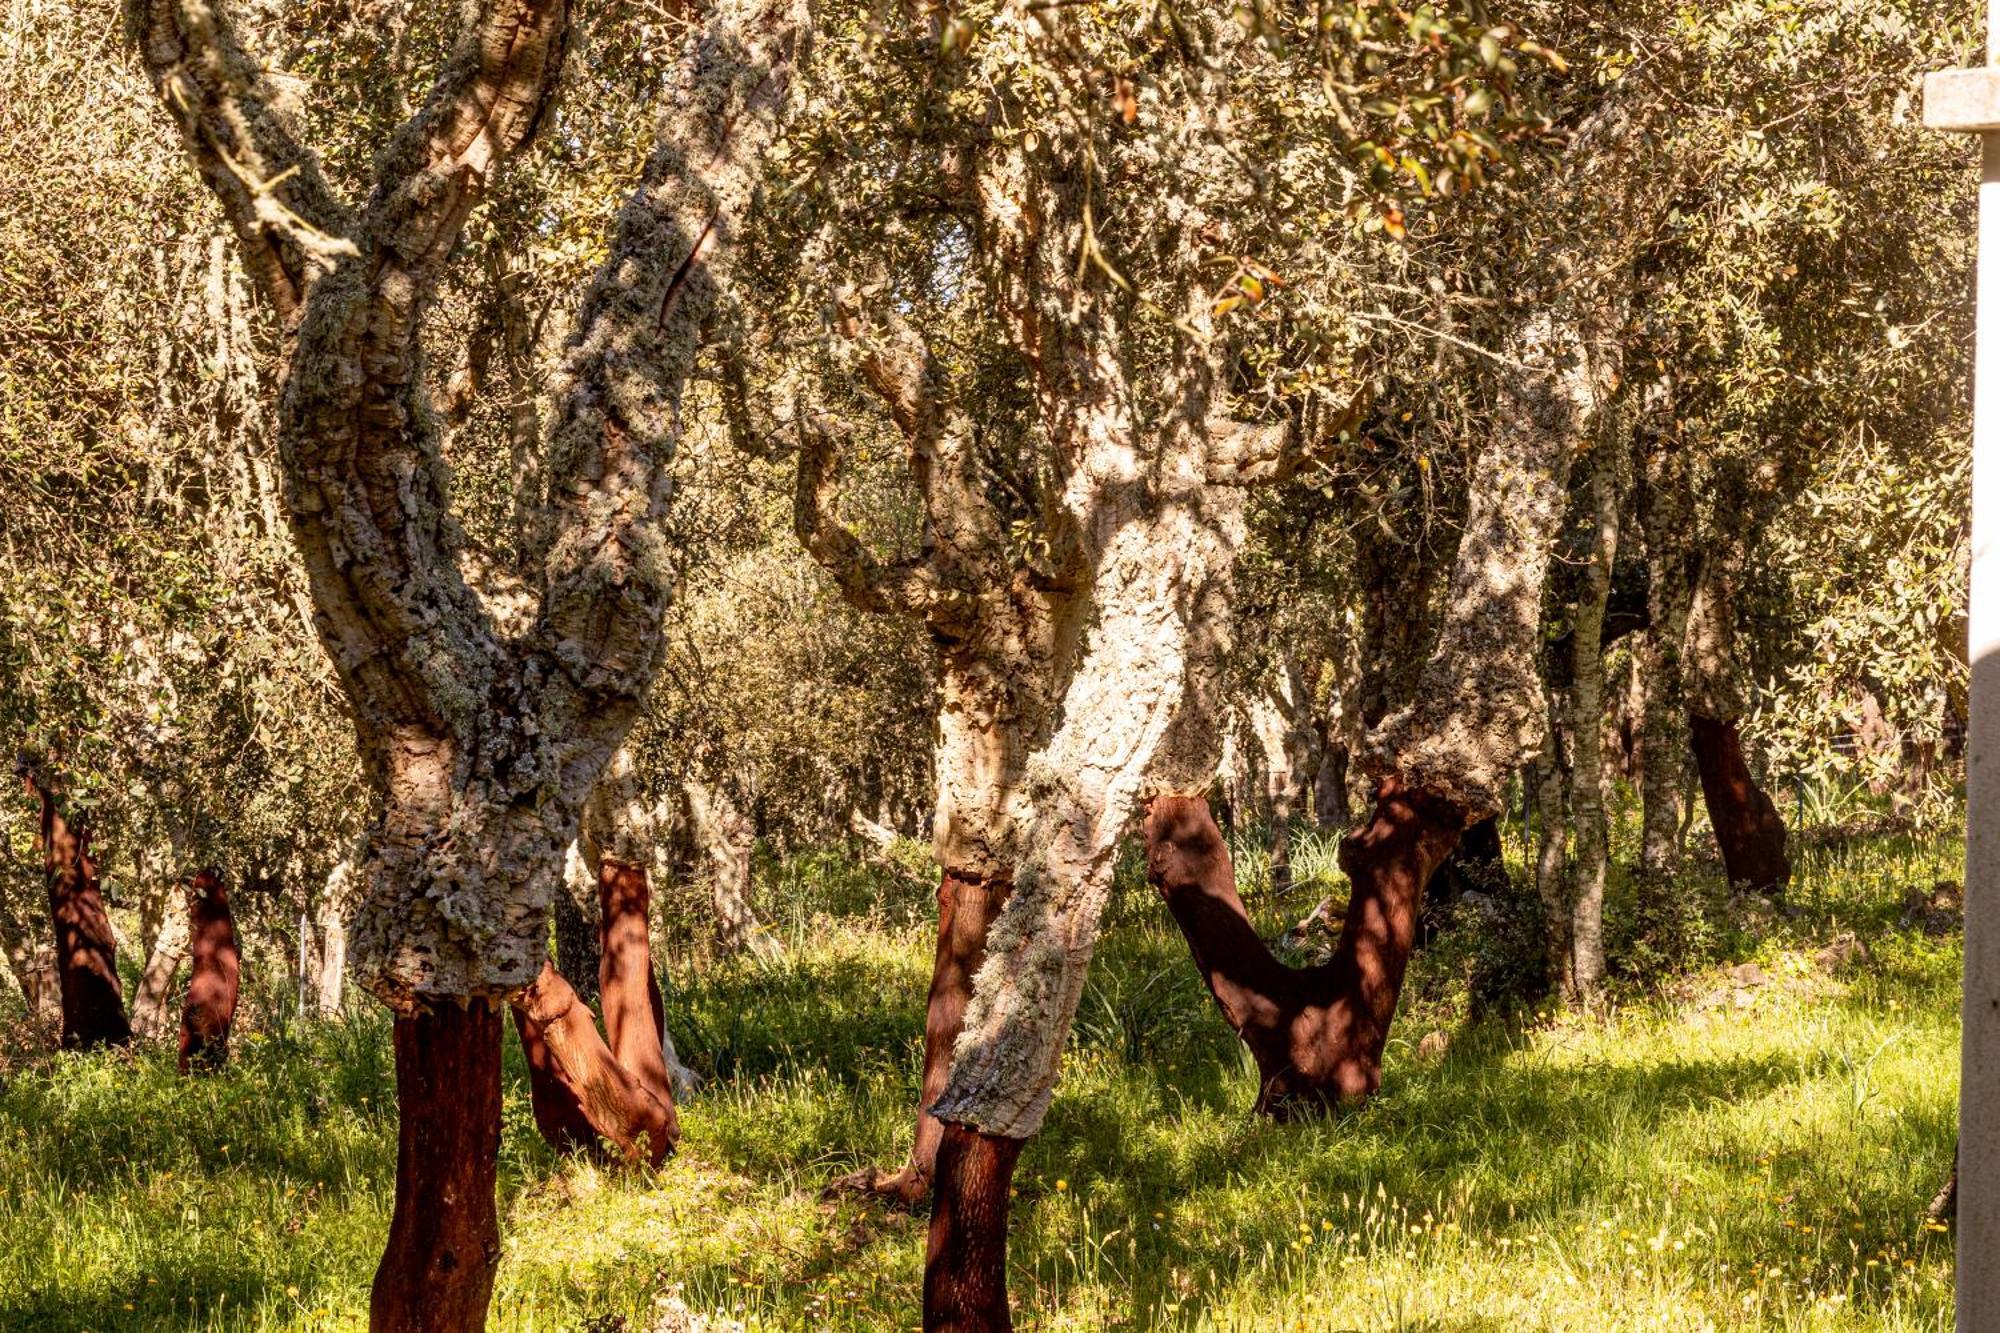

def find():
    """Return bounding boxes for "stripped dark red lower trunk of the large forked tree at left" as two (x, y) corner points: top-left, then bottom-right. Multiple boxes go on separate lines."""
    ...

(368, 1001), (500, 1333)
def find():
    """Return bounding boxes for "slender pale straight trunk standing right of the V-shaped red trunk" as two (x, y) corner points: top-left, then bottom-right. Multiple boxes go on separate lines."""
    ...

(1568, 440), (1630, 1001)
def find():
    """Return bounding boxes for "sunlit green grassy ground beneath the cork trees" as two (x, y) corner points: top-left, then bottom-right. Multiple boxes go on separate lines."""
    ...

(0, 816), (1960, 1331)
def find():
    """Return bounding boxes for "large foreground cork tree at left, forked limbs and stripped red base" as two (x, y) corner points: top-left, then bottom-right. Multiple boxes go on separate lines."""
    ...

(126, 0), (804, 1329)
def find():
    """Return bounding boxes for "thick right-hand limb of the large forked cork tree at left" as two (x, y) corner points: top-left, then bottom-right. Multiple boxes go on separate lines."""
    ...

(536, 0), (806, 773)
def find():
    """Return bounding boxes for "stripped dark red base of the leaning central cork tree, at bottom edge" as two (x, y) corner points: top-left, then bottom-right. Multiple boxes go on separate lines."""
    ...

(924, 1123), (1022, 1333)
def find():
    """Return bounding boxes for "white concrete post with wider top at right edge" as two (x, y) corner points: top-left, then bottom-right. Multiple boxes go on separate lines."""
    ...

(1924, 23), (2000, 1333)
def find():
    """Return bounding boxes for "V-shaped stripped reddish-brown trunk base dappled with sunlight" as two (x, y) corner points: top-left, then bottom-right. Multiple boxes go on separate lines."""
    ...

(1146, 779), (1464, 1119)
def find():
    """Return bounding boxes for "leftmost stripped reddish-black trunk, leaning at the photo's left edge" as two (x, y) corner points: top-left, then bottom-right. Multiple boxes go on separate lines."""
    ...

(22, 773), (132, 1051)
